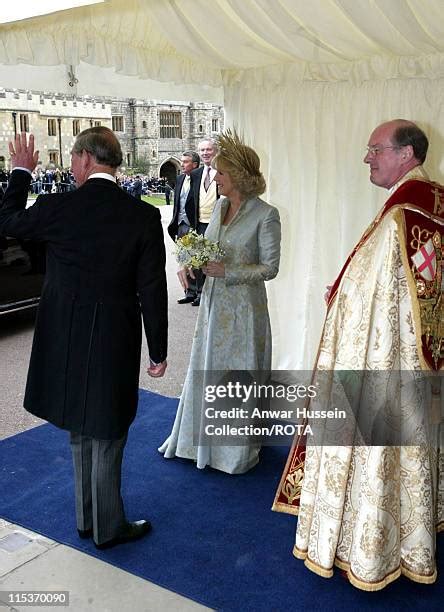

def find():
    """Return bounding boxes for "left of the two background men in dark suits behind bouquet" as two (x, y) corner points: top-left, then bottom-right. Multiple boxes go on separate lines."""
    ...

(168, 151), (200, 304)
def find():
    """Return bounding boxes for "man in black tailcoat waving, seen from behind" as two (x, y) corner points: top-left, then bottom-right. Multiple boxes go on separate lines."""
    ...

(0, 126), (167, 548)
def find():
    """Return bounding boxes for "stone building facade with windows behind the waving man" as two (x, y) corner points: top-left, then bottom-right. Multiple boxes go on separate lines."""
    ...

(0, 89), (224, 182)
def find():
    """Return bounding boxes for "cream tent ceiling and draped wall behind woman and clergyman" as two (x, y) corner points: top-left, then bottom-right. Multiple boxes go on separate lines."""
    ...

(0, 0), (444, 369)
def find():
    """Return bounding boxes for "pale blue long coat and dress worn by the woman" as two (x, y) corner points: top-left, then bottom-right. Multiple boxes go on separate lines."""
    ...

(159, 198), (281, 474)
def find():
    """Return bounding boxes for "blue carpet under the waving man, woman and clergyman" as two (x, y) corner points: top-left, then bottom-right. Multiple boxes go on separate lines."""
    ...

(0, 391), (444, 612)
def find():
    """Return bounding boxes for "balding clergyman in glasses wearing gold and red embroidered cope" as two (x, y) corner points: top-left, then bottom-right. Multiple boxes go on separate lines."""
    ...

(273, 119), (444, 591)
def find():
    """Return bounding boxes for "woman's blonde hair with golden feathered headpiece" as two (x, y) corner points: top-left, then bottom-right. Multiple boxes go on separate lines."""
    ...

(213, 129), (267, 198)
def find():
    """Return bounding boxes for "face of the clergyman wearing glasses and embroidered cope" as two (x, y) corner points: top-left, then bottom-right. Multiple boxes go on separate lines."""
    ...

(364, 124), (405, 189)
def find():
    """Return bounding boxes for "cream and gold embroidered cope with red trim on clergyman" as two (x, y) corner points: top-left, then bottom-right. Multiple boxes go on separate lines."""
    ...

(273, 168), (444, 591)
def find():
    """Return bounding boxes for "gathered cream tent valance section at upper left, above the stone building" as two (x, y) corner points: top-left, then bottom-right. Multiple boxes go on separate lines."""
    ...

(0, 0), (221, 87)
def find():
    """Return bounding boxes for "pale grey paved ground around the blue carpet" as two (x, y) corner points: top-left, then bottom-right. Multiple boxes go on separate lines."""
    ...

(0, 206), (212, 612)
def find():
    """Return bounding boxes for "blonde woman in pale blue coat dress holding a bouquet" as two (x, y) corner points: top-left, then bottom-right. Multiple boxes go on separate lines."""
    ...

(159, 130), (281, 474)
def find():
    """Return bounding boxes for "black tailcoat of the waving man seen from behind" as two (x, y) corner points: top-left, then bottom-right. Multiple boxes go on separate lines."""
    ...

(0, 170), (167, 439)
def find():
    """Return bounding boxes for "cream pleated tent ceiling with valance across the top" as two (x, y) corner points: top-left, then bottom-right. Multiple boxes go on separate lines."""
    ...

(0, 0), (444, 87)
